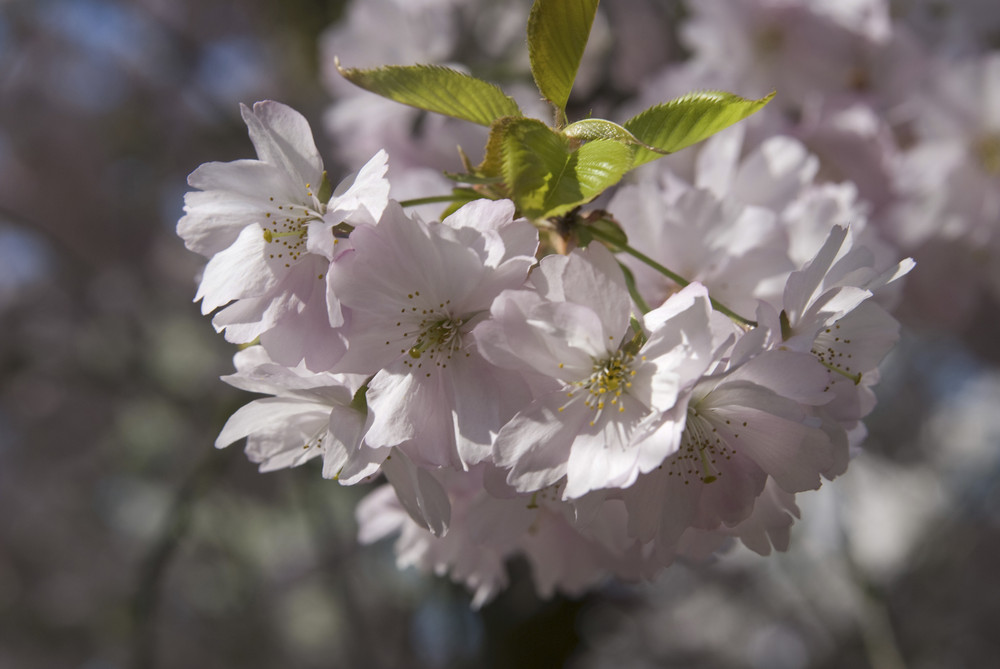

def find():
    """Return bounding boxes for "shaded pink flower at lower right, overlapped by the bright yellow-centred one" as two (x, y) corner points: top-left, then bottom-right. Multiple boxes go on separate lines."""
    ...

(622, 351), (847, 563)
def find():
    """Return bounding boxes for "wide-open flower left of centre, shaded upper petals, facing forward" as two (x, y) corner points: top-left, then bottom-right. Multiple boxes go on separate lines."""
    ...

(329, 200), (538, 468)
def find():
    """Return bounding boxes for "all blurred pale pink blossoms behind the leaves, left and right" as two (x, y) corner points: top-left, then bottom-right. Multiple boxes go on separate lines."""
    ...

(321, 0), (1000, 333)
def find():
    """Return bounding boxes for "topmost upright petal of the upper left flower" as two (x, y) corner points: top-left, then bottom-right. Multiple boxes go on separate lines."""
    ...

(240, 100), (323, 192)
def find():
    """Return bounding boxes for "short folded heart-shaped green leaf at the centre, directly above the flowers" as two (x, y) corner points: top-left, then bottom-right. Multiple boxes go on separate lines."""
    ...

(500, 119), (632, 219)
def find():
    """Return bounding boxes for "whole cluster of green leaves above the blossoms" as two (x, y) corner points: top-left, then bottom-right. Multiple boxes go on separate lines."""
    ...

(337, 0), (773, 220)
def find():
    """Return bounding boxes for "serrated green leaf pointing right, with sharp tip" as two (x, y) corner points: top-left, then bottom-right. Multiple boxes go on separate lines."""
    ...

(625, 91), (774, 167)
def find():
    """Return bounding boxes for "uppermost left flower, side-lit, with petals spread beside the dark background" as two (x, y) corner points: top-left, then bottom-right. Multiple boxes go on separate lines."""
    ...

(177, 101), (389, 371)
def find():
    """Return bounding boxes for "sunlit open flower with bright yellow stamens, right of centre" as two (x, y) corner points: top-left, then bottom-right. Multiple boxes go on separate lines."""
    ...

(477, 244), (714, 498)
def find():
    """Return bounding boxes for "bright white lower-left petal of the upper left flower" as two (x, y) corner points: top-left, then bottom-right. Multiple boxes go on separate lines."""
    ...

(194, 224), (278, 314)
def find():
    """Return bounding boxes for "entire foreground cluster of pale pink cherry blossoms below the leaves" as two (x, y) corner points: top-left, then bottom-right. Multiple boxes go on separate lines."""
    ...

(178, 101), (912, 606)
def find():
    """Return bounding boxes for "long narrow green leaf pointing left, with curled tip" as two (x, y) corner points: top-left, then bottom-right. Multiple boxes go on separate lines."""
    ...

(334, 60), (521, 126)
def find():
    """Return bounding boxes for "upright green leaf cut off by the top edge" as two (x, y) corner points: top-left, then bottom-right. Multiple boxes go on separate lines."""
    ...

(528, 0), (598, 126)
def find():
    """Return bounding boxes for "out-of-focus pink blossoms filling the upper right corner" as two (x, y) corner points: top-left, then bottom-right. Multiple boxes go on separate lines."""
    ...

(612, 0), (1000, 326)
